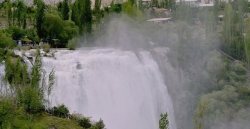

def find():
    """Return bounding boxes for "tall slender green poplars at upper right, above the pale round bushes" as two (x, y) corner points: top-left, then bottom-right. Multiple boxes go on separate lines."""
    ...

(222, 3), (246, 60)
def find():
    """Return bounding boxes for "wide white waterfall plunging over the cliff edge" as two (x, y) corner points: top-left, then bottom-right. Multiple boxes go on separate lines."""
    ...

(43, 49), (176, 129)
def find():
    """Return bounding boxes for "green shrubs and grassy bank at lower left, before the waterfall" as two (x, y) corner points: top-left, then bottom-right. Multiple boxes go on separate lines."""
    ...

(0, 49), (105, 129)
